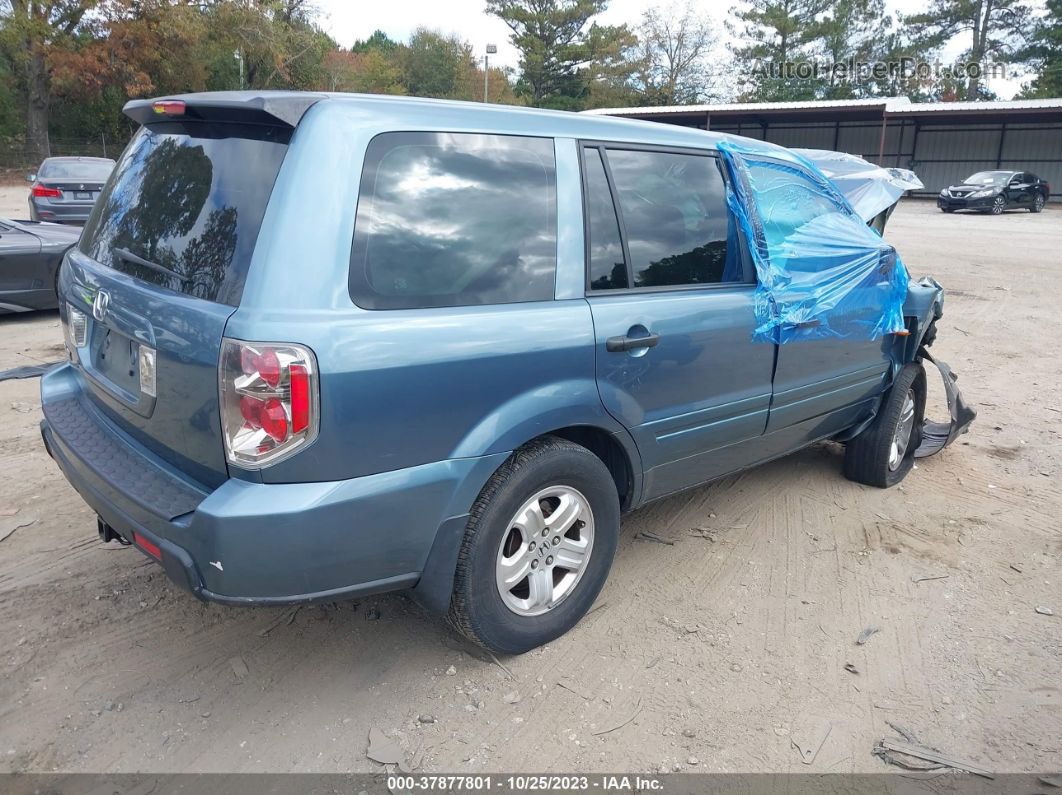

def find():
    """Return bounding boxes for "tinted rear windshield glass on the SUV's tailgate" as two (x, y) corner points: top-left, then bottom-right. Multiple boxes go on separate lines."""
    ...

(81, 123), (291, 306)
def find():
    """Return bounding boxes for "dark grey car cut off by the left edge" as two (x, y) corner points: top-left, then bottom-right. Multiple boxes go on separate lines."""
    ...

(0, 218), (81, 314)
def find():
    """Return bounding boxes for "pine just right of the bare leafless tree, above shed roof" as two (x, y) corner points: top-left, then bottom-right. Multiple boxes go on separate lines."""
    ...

(726, 0), (830, 102)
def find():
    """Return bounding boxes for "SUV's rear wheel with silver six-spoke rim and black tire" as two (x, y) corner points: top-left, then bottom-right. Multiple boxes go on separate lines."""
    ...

(449, 436), (619, 654)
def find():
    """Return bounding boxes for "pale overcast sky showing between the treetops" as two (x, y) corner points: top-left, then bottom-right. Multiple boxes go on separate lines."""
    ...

(315, 0), (1020, 99)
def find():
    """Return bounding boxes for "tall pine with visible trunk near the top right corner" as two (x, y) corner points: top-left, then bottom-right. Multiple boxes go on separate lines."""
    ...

(904, 0), (1032, 100)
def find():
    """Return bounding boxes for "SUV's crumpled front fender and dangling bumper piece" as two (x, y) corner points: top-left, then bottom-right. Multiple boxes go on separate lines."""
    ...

(903, 276), (977, 459)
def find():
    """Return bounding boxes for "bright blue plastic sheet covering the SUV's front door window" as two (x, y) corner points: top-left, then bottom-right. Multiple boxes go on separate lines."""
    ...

(719, 141), (908, 344)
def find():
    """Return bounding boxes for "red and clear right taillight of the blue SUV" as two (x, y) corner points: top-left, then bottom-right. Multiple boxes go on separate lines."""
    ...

(219, 340), (319, 469)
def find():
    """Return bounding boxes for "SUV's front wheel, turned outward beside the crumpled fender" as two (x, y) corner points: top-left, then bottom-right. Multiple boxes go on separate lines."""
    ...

(844, 362), (926, 488)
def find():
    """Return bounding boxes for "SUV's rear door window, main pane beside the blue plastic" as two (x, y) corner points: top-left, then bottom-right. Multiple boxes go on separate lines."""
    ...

(607, 150), (741, 288)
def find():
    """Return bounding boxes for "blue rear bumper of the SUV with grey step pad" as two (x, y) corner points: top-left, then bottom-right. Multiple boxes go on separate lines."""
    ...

(41, 365), (503, 605)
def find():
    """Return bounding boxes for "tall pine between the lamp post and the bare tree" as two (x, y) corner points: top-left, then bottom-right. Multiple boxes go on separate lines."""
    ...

(486, 0), (632, 109)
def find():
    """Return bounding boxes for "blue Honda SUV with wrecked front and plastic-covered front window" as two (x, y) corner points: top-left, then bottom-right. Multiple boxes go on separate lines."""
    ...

(41, 92), (972, 653)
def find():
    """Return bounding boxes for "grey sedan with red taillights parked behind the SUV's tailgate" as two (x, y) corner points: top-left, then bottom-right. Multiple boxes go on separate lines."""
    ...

(27, 157), (115, 224)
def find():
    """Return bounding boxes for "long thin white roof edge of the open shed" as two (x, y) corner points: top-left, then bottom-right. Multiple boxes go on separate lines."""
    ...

(583, 97), (1062, 116)
